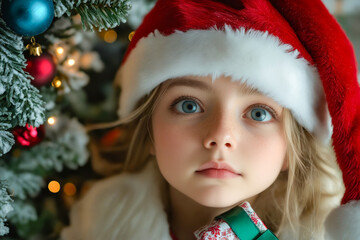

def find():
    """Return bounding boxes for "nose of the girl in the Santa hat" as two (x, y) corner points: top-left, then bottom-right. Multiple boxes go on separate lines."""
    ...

(203, 110), (237, 150)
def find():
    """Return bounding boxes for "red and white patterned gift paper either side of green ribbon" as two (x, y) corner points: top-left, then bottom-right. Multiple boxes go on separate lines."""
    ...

(194, 202), (267, 240)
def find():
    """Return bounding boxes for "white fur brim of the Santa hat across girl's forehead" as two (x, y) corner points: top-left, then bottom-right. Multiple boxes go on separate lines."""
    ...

(117, 26), (332, 141)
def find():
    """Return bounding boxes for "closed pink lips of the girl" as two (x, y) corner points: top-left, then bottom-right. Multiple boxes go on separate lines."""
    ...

(196, 161), (241, 178)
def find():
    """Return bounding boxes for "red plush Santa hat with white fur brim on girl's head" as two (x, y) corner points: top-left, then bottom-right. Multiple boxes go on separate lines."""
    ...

(117, 0), (360, 235)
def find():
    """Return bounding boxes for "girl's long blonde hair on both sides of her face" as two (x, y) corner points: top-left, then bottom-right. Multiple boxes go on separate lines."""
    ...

(115, 85), (344, 240)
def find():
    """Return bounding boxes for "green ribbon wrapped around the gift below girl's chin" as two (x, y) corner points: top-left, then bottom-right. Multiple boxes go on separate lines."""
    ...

(216, 207), (278, 240)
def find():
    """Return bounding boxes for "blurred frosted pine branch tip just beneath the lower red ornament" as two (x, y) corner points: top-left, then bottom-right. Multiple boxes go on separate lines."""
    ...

(12, 117), (89, 172)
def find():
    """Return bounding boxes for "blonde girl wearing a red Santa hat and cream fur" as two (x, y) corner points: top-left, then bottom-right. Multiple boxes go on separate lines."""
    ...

(62, 0), (360, 240)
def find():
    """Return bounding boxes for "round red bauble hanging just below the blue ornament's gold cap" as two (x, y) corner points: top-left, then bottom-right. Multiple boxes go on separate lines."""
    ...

(25, 53), (56, 87)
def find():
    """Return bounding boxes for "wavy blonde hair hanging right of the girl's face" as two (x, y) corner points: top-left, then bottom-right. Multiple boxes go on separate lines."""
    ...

(253, 109), (344, 240)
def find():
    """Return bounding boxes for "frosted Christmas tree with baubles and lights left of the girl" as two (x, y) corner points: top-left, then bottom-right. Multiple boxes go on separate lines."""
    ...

(0, 0), (158, 239)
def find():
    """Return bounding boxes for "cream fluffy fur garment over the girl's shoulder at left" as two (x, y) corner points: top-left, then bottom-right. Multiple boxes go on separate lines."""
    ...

(61, 163), (171, 240)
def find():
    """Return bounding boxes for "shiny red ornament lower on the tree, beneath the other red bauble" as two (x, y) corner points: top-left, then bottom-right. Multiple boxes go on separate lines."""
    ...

(12, 124), (45, 147)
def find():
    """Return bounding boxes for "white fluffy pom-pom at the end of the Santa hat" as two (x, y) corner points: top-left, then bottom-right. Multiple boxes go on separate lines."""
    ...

(325, 201), (360, 240)
